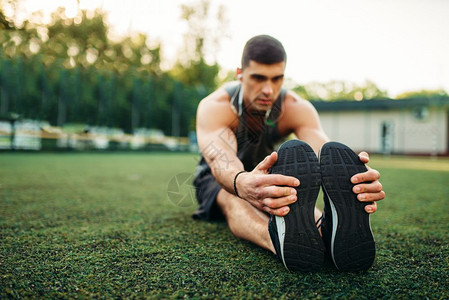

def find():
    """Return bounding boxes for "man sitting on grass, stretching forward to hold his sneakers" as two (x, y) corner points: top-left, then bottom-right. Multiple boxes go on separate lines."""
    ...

(194, 35), (385, 271)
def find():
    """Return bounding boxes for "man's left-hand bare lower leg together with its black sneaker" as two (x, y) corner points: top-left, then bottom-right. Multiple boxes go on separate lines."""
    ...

(216, 140), (324, 271)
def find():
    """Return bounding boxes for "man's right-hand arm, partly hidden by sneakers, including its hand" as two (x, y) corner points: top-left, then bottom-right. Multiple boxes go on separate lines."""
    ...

(279, 92), (385, 213)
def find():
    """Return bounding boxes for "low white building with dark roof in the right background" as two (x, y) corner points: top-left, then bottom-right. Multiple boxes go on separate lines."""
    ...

(312, 97), (449, 155)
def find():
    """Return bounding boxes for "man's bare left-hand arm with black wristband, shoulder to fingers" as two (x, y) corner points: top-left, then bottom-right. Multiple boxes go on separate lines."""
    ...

(197, 89), (299, 215)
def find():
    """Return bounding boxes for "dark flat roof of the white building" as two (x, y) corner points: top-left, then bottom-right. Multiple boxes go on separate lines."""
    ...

(311, 96), (449, 111)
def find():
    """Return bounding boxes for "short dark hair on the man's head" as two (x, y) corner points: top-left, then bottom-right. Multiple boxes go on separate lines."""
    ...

(242, 35), (287, 69)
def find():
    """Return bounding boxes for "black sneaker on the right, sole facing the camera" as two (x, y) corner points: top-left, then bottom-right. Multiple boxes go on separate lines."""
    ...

(319, 142), (376, 271)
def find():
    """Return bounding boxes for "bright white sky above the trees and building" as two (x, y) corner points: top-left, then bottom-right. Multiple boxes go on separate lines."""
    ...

(19, 0), (449, 97)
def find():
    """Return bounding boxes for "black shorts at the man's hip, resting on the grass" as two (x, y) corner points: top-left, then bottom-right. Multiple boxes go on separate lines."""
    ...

(193, 165), (225, 221)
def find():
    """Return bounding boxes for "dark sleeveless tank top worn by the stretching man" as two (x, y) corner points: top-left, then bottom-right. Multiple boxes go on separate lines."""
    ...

(196, 81), (287, 176)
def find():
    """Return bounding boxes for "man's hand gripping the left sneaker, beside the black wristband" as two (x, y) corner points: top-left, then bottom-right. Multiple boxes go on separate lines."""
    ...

(236, 152), (300, 216)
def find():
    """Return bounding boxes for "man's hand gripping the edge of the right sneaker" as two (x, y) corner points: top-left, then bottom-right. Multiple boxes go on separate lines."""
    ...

(351, 152), (385, 214)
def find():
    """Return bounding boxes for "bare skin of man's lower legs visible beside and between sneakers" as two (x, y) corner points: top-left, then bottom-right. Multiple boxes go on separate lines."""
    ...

(217, 189), (322, 253)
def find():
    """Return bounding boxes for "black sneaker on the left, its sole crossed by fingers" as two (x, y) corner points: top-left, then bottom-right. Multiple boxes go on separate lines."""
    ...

(268, 140), (324, 272)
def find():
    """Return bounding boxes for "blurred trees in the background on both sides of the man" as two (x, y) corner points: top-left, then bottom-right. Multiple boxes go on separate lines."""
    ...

(4, 0), (447, 136)
